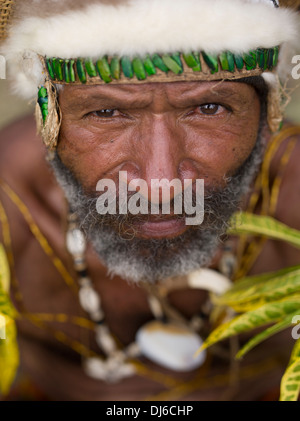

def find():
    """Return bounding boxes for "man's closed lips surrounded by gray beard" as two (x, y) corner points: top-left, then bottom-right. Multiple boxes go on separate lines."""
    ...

(133, 218), (188, 238)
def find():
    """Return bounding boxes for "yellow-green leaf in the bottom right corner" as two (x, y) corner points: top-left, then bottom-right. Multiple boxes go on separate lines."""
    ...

(280, 339), (300, 401)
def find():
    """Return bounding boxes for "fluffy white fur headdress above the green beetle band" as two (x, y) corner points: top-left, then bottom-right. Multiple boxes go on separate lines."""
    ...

(0, 0), (298, 97)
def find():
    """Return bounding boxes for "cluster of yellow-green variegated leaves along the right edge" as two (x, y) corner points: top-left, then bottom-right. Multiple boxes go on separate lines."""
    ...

(201, 213), (300, 401)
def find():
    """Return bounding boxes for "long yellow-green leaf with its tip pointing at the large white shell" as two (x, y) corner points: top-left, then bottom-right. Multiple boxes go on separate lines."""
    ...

(201, 295), (300, 349)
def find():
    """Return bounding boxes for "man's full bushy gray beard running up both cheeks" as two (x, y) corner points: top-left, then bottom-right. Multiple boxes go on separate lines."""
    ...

(51, 135), (264, 283)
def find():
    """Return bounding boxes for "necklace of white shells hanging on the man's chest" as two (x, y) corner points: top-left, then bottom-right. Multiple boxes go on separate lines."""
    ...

(66, 213), (231, 383)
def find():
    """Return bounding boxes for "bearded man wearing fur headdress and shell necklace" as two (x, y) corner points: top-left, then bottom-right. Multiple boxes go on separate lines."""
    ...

(0, 0), (300, 400)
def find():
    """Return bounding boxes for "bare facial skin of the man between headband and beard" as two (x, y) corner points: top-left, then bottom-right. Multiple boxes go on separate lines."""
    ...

(58, 82), (260, 197)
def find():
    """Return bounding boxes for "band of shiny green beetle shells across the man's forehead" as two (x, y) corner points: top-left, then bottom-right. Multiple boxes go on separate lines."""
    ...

(42, 47), (279, 84)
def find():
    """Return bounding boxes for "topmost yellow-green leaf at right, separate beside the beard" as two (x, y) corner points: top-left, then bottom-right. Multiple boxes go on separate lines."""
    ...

(229, 212), (300, 248)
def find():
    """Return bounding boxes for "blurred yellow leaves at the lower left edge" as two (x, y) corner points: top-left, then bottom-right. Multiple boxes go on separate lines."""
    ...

(0, 244), (19, 395)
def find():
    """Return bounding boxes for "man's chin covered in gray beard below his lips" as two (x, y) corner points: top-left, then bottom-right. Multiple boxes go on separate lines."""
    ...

(89, 223), (219, 283)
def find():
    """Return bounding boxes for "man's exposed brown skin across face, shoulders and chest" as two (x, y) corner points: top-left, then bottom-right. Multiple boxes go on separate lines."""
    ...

(0, 82), (300, 400)
